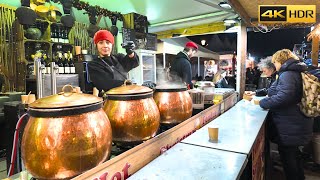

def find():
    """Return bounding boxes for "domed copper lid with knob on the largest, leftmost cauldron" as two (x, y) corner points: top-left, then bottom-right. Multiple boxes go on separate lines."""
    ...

(29, 85), (103, 109)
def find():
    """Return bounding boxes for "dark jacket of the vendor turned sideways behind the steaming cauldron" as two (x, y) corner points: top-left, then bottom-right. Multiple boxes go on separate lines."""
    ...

(170, 52), (193, 88)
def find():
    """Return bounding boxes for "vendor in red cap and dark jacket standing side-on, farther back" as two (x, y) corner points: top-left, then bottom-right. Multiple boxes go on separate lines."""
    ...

(170, 41), (198, 88)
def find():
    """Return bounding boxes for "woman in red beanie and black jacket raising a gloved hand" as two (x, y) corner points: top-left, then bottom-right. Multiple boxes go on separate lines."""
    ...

(88, 30), (139, 92)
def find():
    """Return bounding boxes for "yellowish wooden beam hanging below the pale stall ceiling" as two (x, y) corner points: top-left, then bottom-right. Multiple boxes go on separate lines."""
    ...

(156, 22), (226, 39)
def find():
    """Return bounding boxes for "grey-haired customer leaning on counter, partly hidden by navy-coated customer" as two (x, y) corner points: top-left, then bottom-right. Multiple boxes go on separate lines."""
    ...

(245, 57), (277, 96)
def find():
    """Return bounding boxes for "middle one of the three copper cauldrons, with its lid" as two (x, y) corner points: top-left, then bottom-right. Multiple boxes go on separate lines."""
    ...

(103, 85), (160, 146)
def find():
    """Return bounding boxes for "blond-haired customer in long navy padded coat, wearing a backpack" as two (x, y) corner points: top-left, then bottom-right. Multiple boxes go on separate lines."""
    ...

(259, 49), (313, 180)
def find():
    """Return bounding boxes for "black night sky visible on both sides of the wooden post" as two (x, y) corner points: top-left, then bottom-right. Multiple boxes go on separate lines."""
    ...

(188, 28), (310, 59)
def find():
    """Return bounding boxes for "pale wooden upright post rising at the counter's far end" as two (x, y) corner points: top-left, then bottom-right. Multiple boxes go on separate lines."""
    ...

(236, 22), (247, 100)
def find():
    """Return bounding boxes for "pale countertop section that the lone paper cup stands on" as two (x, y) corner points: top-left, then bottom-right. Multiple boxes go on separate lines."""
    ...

(182, 100), (268, 154)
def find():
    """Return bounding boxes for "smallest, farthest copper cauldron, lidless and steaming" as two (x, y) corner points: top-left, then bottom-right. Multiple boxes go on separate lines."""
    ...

(153, 86), (192, 125)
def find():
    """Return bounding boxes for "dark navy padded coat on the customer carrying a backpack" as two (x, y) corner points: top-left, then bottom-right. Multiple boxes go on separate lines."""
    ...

(260, 59), (313, 146)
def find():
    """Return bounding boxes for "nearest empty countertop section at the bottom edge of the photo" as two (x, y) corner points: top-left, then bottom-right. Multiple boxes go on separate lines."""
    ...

(129, 143), (247, 180)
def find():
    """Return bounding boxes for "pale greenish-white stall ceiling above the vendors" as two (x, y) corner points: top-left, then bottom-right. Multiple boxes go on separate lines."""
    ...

(80, 0), (237, 33)
